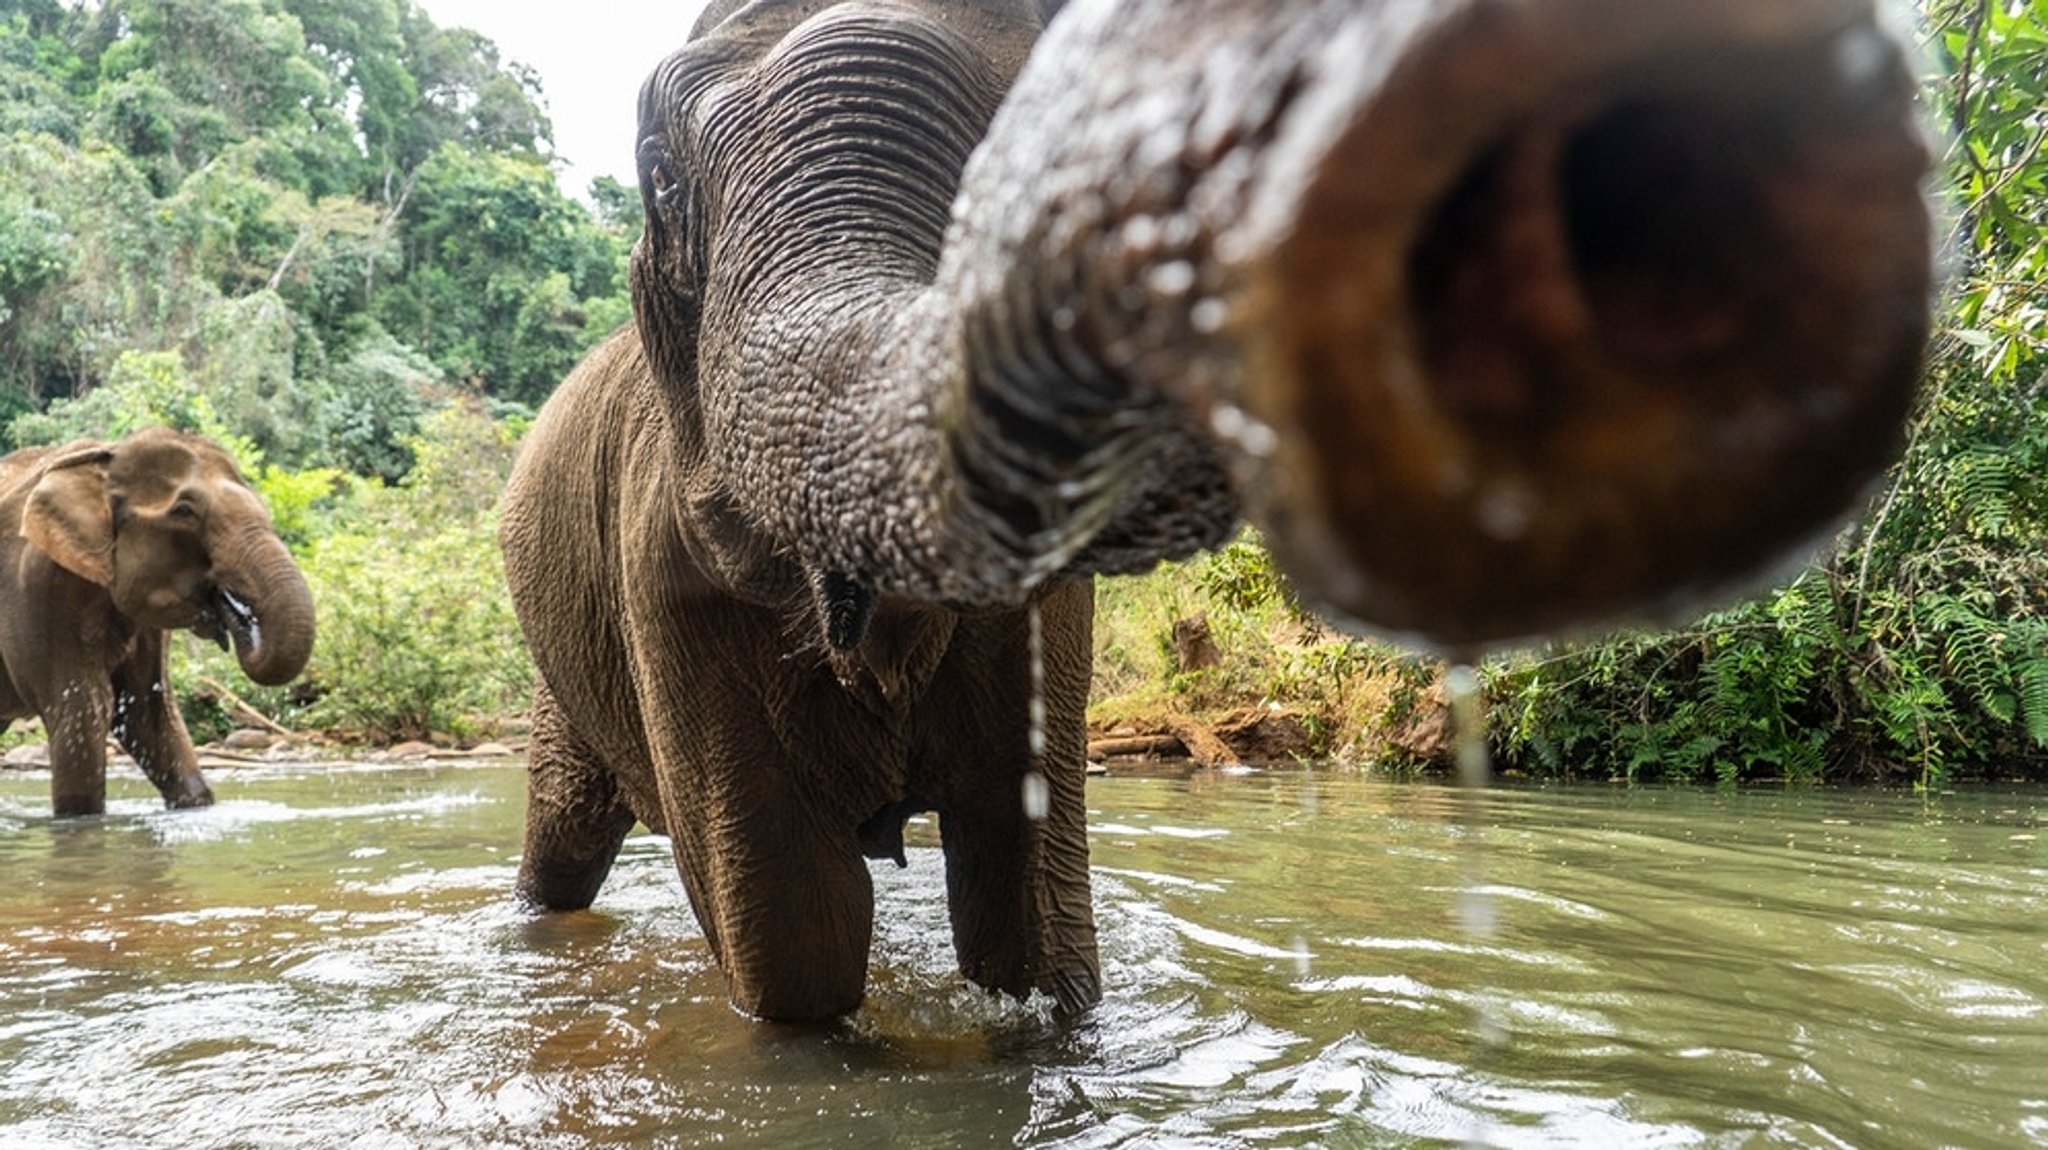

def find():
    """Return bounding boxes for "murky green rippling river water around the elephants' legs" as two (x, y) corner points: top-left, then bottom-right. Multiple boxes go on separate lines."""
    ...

(0, 765), (2048, 1148)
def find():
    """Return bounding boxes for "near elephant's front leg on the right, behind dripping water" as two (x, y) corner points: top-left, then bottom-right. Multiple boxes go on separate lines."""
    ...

(924, 581), (1102, 1013)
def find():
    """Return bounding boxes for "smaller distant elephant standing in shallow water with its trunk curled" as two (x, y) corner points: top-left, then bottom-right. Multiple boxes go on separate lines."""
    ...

(0, 428), (313, 816)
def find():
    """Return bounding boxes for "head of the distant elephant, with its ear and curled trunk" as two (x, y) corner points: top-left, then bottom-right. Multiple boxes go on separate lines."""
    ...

(20, 428), (313, 683)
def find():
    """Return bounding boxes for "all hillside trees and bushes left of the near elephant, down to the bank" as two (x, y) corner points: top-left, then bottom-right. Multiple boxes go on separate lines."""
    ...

(0, 0), (639, 739)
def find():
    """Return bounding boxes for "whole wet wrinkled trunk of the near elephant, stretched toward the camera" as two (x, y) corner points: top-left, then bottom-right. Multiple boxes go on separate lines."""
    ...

(741, 0), (1931, 651)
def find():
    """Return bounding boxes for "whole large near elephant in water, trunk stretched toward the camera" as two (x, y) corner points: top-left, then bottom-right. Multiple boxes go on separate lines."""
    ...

(500, 0), (1931, 1019)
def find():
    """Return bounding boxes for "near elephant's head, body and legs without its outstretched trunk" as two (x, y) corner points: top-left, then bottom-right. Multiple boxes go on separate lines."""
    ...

(502, 4), (1100, 1019)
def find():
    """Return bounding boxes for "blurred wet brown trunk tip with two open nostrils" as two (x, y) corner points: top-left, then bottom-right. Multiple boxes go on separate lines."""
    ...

(1243, 0), (1933, 649)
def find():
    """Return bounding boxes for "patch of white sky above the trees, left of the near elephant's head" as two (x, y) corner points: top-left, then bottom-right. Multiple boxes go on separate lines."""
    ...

(414, 0), (705, 198)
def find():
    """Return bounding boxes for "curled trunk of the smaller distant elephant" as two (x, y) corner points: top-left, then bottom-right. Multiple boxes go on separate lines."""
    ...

(213, 528), (313, 685)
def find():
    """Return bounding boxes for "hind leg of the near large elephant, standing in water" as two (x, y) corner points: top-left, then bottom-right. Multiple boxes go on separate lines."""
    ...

(518, 683), (633, 911)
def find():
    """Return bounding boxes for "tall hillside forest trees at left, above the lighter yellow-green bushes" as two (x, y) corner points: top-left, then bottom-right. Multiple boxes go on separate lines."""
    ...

(0, 0), (639, 470)
